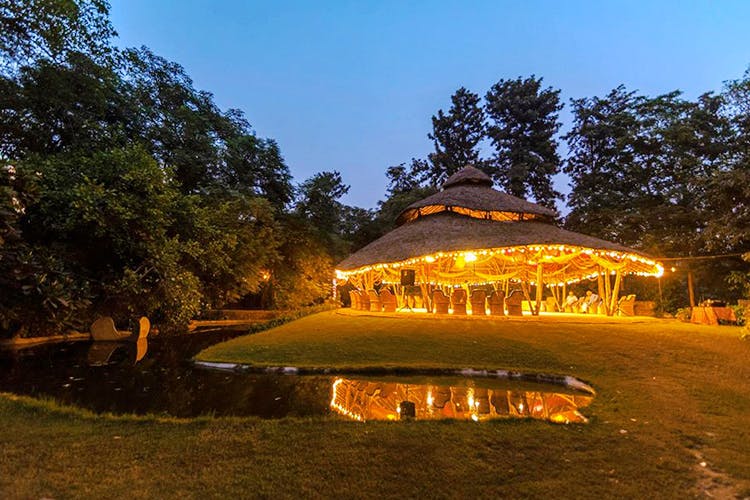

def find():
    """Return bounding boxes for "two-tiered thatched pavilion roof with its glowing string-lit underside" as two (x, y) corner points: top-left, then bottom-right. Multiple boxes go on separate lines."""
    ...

(336, 166), (663, 316)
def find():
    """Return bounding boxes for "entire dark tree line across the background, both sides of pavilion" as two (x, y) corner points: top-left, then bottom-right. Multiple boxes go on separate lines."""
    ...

(0, 0), (750, 334)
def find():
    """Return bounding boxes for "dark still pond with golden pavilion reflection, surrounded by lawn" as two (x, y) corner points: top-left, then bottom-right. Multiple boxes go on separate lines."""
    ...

(0, 332), (593, 423)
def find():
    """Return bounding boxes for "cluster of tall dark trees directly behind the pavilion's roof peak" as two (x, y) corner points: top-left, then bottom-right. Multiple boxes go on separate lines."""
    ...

(388, 76), (562, 208)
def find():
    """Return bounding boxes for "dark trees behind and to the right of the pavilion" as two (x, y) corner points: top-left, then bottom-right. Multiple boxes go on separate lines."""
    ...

(352, 76), (750, 310)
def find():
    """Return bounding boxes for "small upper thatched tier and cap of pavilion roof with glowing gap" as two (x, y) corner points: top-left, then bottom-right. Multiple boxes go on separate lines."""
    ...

(396, 167), (556, 225)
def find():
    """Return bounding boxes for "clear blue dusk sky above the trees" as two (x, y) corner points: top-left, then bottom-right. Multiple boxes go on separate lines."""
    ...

(111, 0), (750, 211)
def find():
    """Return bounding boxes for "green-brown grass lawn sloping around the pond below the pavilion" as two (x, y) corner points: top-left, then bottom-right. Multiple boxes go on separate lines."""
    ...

(0, 312), (750, 498)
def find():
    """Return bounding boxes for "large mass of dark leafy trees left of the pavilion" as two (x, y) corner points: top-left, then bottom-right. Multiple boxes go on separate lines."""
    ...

(0, 0), (347, 335)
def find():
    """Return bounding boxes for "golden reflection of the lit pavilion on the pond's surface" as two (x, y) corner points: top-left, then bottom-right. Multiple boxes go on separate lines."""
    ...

(330, 378), (594, 424)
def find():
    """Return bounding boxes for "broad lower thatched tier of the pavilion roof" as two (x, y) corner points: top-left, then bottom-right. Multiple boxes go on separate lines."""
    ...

(336, 212), (647, 271)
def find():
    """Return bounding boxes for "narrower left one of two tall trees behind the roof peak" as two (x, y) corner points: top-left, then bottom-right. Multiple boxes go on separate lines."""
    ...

(428, 87), (485, 186)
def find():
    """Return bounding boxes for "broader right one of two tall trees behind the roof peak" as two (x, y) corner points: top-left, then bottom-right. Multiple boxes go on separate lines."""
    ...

(485, 75), (562, 208)
